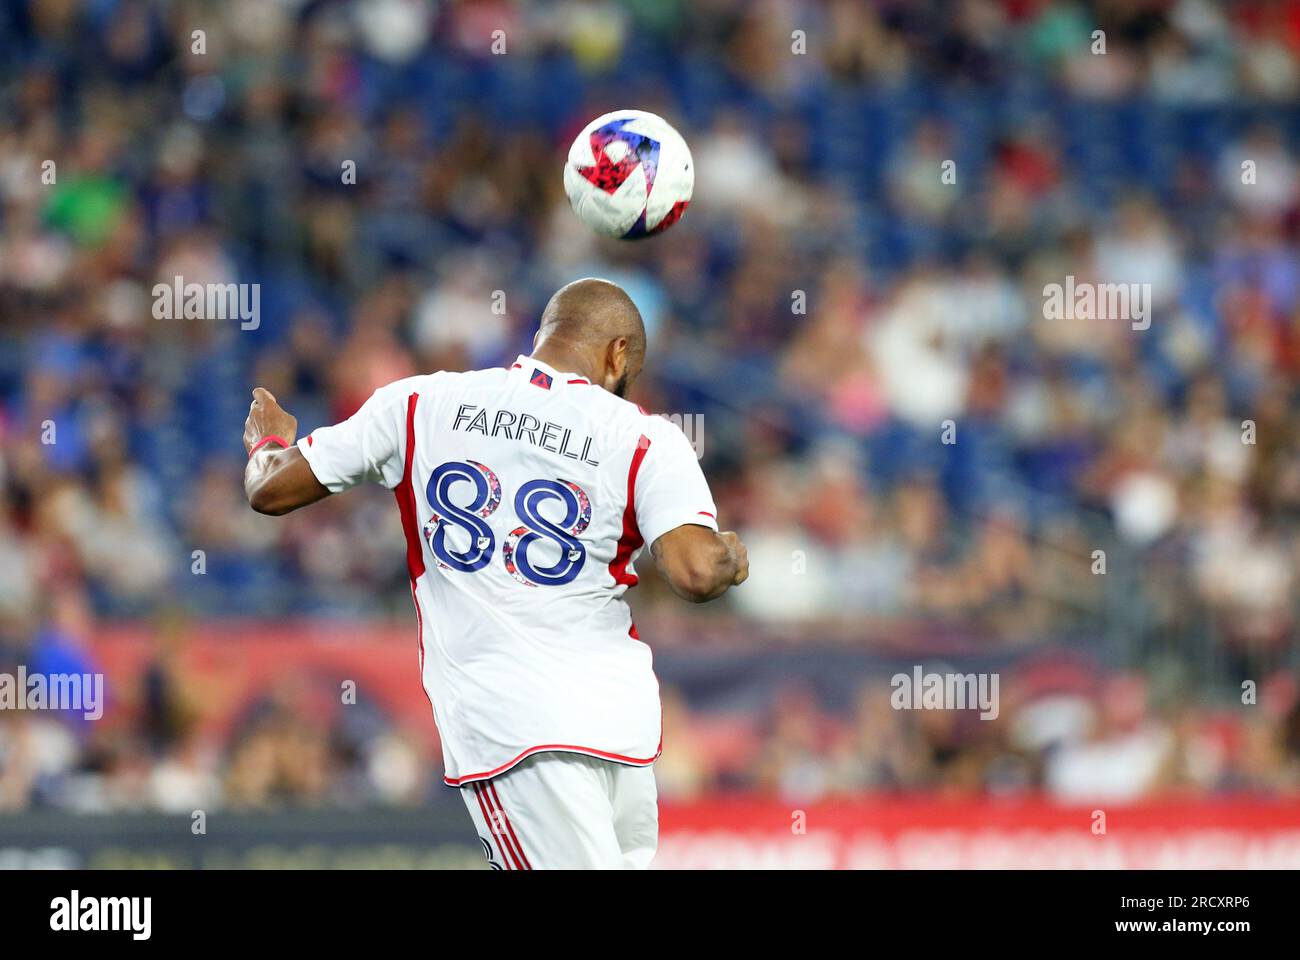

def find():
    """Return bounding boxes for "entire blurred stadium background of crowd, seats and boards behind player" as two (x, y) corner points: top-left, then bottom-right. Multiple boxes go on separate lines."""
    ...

(0, 0), (1300, 866)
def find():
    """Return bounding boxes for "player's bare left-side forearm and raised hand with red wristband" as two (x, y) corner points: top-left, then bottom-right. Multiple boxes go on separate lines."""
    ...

(244, 386), (330, 516)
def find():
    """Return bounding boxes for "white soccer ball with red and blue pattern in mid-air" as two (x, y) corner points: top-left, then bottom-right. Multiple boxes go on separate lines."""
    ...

(564, 111), (696, 239)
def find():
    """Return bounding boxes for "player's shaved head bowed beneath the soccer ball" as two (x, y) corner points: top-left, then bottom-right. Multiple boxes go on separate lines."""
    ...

(533, 277), (646, 397)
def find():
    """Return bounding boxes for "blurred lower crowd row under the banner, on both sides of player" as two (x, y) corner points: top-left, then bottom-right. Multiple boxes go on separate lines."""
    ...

(0, 657), (1300, 814)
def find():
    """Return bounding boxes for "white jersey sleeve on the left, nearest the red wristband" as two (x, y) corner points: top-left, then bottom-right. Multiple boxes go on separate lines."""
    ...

(298, 381), (410, 493)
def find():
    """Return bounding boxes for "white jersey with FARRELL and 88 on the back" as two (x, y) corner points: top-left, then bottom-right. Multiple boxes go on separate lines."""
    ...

(298, 356), (718, 786)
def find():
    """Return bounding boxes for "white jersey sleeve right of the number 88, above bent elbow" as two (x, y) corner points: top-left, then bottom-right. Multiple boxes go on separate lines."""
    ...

(634, 418), (718, 544)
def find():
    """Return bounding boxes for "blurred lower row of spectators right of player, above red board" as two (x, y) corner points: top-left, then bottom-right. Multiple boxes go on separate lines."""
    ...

(655, 674), (1300, 804)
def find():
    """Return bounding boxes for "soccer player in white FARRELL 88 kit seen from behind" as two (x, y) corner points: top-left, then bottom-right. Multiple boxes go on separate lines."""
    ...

(244, 280), (749, 870)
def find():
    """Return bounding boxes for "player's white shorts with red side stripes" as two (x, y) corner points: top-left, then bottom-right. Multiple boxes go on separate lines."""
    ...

(460, 753), (659, 870)
